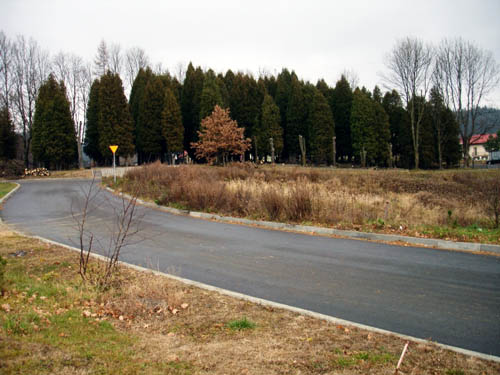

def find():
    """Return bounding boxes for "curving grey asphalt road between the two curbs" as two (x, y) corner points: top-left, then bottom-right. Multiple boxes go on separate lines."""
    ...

(0, 180), (500, 356)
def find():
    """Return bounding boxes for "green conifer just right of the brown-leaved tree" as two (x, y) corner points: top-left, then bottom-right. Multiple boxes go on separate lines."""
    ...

(255, 94), (283, 157)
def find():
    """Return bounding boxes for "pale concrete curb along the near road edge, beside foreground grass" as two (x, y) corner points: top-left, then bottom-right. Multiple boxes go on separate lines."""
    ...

(7, 232), (500, 363)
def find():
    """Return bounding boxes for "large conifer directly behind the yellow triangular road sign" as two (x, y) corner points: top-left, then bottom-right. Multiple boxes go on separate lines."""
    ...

(98, 72), (135, 162)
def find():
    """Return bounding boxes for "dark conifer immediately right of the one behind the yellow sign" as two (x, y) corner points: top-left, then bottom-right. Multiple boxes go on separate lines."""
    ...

(136, 76), (166, 163)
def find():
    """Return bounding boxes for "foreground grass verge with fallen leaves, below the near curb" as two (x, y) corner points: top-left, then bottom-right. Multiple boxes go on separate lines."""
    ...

(0, 225), (500, 374)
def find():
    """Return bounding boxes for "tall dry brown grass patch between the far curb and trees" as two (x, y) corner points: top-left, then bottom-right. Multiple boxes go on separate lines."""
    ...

(115, 163), (500, 243)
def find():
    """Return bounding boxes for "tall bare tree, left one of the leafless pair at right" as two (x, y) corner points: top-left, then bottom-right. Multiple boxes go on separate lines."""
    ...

(384, 37), (434, 169)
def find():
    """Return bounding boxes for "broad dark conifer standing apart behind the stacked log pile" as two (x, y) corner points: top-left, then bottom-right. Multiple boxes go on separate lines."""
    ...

(32, 74), (78, 169)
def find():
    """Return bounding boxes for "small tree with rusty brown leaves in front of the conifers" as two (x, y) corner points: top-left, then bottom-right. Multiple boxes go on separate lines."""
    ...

(191, 105), (251, 165)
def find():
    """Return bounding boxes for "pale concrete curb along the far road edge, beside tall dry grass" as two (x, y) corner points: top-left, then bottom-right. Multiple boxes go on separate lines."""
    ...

(105, 187), (500, 254)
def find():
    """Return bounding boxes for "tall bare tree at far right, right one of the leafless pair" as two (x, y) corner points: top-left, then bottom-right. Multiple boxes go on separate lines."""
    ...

(434, 38), (500, 166)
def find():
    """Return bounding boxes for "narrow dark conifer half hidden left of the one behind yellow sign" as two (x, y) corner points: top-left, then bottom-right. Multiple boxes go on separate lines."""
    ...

(83, 79), (104, 164)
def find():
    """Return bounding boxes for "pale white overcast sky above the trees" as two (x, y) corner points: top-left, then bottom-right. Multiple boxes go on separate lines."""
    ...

(0, 0), (500, 108)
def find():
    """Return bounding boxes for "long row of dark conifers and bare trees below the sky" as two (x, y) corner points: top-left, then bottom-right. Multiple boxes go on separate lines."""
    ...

(0, 33), (499, 168)
